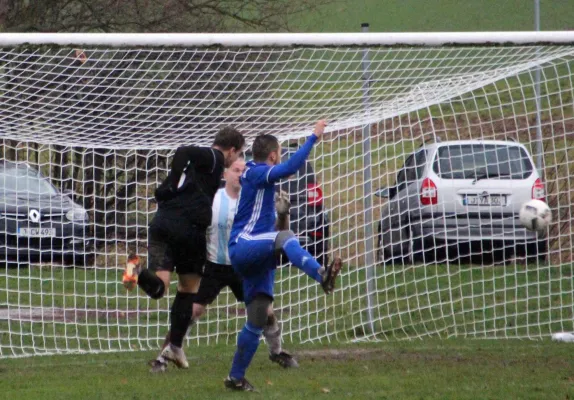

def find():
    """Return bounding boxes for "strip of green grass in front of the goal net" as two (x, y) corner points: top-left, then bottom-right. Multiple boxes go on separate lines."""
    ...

(0, 340), (574, 400)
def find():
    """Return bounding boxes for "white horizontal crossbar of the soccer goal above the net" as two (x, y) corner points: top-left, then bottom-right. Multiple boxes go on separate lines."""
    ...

(0, 31), (574, 47)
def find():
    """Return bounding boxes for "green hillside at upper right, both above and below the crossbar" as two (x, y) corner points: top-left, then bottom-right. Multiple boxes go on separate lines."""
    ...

(273, 0), (574, 141)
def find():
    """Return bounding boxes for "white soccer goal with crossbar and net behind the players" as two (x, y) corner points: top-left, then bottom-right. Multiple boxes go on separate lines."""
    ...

(0, 32), (574, 357)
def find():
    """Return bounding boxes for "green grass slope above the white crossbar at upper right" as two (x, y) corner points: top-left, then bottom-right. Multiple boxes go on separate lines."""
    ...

(291, 0), (574, 32)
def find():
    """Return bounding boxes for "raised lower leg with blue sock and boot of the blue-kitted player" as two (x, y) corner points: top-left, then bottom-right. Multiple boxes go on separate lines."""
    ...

(274, 231), (342, 294)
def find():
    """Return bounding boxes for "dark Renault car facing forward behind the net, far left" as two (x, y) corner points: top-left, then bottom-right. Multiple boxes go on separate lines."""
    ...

(0, 162), (94, 265)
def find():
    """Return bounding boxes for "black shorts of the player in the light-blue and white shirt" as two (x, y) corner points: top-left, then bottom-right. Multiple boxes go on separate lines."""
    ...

(194, 261), (243, 306)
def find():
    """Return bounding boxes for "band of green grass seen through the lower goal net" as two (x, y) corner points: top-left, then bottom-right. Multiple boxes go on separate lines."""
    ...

(0, 263), (574, 356)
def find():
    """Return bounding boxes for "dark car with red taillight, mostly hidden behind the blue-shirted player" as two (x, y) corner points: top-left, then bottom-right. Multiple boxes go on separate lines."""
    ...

(245, 146), (329, 265)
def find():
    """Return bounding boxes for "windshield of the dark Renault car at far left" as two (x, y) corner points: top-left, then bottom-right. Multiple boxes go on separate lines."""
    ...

(0, 167), (58, 196)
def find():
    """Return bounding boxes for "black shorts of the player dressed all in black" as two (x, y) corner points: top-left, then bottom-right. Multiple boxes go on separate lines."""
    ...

(148, 213), (207, 275)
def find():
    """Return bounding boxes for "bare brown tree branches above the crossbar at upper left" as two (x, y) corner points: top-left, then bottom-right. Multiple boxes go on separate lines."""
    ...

(0, 0), (334, 32)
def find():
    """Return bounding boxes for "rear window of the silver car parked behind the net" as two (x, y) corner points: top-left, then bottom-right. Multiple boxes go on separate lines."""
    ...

(433, 144), (533, 179)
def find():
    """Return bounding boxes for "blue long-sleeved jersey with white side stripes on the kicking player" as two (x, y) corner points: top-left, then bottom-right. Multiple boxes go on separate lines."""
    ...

(229, 135), (317, 245)
